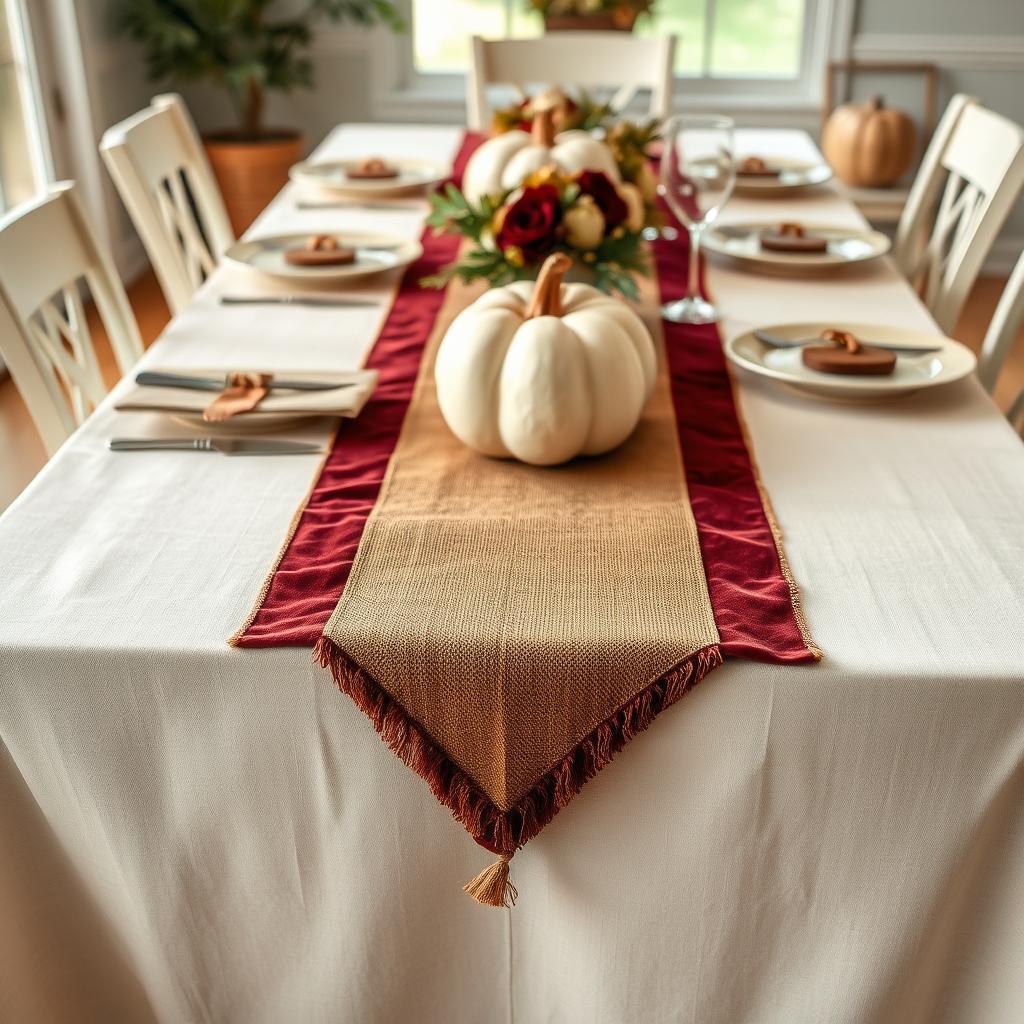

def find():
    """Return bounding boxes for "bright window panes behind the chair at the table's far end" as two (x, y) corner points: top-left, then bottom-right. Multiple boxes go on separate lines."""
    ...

(413, 0), (812, 80)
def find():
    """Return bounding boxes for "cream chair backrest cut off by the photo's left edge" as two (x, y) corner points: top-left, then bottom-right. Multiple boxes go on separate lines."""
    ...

(0, 181), (142, 455)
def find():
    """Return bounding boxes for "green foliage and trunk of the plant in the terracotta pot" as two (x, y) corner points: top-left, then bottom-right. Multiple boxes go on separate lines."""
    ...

(115, 0), (403, 140)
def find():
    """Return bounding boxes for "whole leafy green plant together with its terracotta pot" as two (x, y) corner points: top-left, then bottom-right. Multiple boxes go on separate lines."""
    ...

(116, 0), (402, 233)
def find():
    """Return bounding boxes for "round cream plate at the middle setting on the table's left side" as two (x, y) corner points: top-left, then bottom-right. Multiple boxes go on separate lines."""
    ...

(224, 231), (423, 282)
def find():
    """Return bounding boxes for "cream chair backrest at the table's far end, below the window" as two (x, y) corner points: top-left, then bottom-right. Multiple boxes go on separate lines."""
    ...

(466, 32), (676, 131)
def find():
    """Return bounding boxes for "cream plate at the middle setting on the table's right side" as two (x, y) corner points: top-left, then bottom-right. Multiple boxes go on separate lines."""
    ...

(700, 220), (891, 273)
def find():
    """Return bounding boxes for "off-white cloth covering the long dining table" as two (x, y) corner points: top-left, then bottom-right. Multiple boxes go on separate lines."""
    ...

(0, 124), (1024, 1024)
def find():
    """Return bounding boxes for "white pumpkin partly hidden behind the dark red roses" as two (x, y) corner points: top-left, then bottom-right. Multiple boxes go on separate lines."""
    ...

(462, 108), (621, 203)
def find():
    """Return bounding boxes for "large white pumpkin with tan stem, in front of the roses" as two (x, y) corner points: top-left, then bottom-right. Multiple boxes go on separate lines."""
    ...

(434, 253), (656, 466)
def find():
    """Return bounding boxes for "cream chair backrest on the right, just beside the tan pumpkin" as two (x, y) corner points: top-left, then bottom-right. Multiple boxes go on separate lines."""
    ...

(893, 95), (1024, 332)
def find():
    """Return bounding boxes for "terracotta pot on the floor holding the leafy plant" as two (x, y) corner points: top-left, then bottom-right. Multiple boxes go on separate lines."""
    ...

(203, 131), (302, 234)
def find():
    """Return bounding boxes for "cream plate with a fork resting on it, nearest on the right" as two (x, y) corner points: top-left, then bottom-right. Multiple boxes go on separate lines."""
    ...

(725, 321), (977, 401)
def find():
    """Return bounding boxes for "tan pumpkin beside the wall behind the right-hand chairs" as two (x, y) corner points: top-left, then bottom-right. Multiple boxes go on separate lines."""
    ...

(821, 96), (918, 188)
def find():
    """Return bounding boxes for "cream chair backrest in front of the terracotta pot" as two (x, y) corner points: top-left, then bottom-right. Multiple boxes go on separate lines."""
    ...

(99, 94), (234, 313)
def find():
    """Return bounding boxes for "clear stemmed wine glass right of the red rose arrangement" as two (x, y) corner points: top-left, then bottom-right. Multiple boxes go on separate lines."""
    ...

(658, 115), (736, 324)
